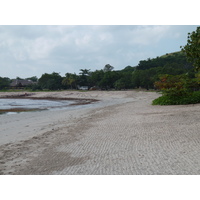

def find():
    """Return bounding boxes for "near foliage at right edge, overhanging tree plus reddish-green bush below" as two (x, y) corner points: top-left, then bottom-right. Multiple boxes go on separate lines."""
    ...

(152, 27), (200, 105)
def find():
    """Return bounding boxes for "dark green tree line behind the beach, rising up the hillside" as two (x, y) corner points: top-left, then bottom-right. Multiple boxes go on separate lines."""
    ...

(0, 52), (195, 90)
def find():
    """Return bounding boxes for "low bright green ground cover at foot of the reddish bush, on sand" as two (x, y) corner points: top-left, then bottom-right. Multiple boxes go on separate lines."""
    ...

(152, 91), (200, 105)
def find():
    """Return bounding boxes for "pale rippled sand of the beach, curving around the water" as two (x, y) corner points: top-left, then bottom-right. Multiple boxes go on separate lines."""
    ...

(0, 91), (200, 175)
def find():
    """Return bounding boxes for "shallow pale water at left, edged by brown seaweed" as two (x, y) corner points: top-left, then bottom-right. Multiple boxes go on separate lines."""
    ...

(0, 99), (74, 110)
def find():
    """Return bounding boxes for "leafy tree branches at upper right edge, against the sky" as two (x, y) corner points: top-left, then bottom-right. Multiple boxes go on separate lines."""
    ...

(181, 26), (200, 71)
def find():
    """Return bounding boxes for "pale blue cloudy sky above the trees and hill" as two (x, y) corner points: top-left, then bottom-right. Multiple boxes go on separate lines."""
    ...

(0, 25), (197, 78)
